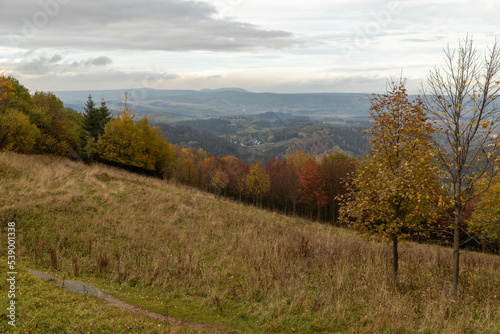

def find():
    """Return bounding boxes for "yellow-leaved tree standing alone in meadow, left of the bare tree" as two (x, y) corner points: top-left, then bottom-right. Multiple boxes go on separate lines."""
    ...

(340, 81), (436, 282)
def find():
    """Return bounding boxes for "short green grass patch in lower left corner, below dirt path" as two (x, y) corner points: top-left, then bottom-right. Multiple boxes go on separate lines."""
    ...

(0, 257), (210, 334)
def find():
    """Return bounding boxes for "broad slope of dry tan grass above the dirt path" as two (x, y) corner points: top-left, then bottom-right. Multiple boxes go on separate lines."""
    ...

(0, 153), (500, 333)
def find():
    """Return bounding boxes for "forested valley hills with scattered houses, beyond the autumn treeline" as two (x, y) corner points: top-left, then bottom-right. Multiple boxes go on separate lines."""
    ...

(158, 113), (370, 163)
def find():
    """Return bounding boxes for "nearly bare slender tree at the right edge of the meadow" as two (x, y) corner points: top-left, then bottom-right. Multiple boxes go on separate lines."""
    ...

(424, 36), (500, 298)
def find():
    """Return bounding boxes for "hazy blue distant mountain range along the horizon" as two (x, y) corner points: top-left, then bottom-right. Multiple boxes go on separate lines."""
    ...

(54, 88), (371, 122)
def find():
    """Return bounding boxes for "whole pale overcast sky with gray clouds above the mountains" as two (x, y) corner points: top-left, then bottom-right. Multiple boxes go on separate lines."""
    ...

(0, 0), (500, 93)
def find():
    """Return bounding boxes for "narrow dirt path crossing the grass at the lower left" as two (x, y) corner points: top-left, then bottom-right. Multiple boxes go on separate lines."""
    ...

(28, 269), (224, 333)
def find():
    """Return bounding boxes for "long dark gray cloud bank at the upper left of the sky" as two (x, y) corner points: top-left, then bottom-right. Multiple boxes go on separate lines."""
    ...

(0, 0), (296, 51)
